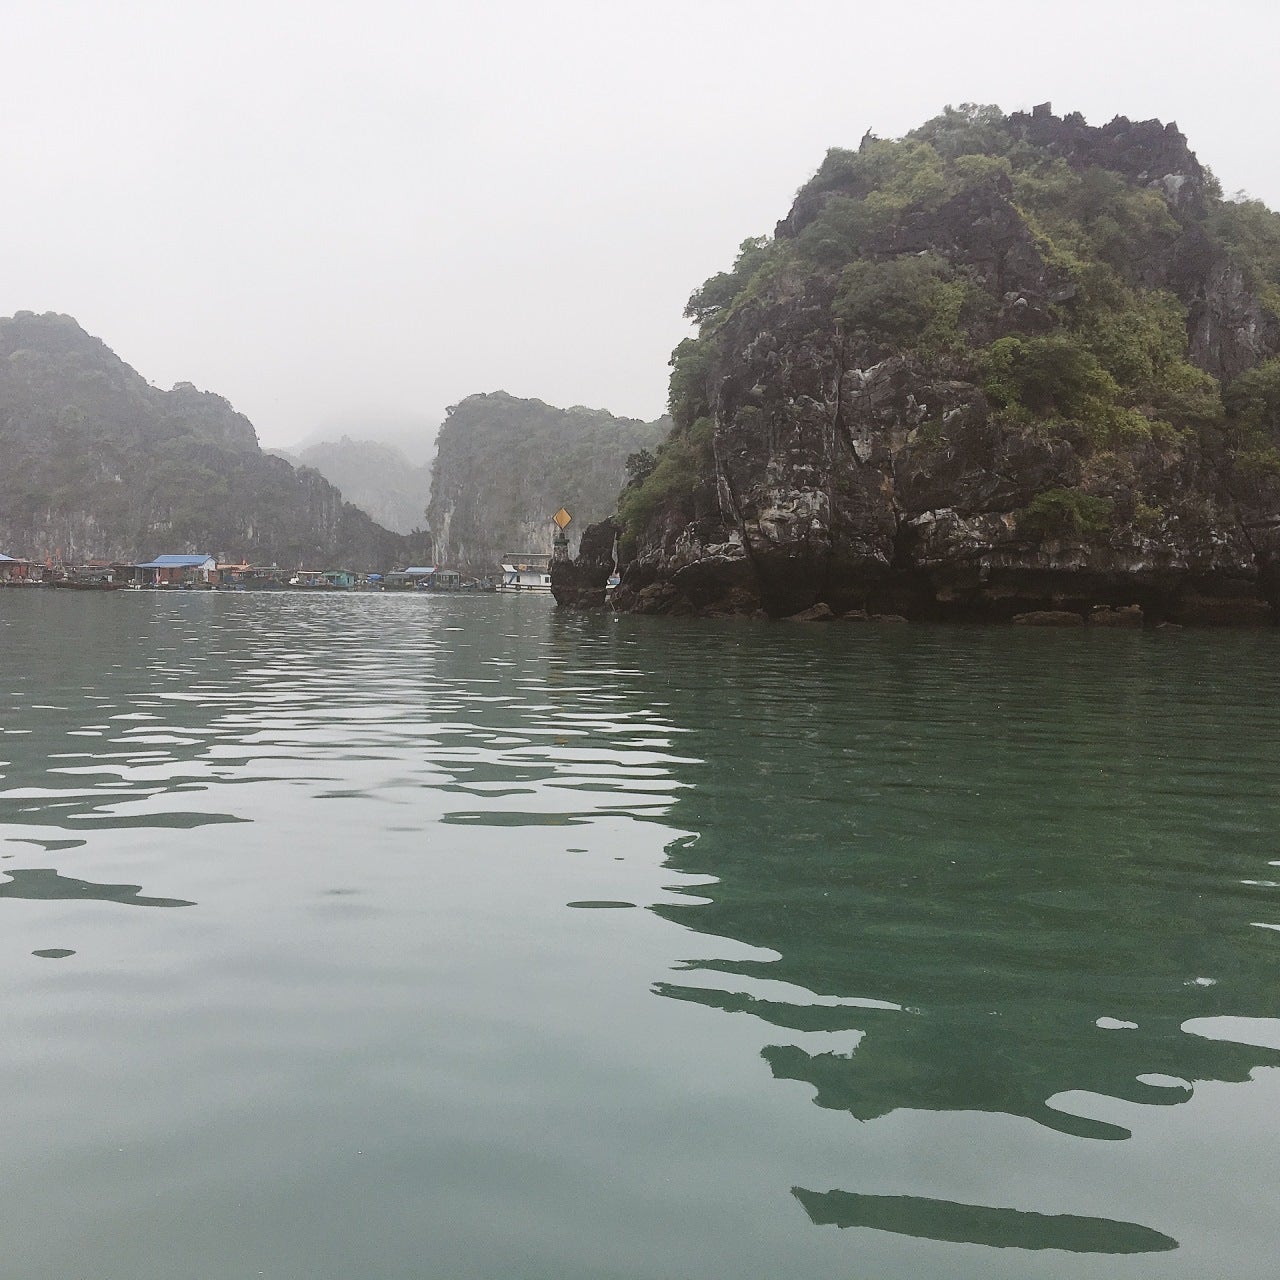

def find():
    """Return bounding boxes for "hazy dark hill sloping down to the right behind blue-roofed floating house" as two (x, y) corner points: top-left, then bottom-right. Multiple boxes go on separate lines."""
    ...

(0, 312), (421, 570)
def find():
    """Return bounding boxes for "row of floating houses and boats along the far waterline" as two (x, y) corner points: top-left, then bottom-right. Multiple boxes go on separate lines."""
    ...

(0, 552), (560, 591)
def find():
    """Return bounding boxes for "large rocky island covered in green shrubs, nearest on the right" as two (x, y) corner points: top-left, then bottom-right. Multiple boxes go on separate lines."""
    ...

(596, 109), (1280, 621)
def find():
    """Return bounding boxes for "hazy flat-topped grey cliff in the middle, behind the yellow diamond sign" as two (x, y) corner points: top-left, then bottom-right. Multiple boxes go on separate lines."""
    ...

(428, 392), (671, 573)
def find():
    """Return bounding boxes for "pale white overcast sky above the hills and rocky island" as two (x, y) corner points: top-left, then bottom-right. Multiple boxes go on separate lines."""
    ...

(0, 0), (1280, 445)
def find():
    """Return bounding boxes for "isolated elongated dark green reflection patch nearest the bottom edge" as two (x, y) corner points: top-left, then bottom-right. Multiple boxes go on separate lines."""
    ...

(792, 1187), (1178, 1253)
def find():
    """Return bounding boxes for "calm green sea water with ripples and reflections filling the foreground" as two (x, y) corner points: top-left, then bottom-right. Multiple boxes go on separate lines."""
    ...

(0, 590), (1280, 1280)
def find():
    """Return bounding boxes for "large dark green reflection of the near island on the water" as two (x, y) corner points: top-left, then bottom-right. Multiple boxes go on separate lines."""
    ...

(586, 627), (1280, 1137)
